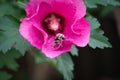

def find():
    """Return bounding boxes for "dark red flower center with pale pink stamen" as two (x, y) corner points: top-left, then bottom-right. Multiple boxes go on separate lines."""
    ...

(43, 13), (64, 35)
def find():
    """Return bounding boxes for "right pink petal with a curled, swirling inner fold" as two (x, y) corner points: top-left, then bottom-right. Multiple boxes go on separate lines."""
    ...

(64, 18), (90, 47)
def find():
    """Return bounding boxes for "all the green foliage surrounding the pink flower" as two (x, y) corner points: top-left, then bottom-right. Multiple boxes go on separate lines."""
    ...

(0, 0), (120, 80)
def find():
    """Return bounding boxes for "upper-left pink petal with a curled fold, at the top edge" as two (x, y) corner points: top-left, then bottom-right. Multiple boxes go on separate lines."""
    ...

(26, 1), (52, 21)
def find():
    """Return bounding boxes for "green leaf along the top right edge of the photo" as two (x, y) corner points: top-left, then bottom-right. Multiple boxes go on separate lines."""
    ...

(84, 0), (120, 8)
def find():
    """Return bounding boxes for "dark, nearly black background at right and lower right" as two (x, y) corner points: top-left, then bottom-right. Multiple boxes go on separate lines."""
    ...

(73, 8), (120, 80)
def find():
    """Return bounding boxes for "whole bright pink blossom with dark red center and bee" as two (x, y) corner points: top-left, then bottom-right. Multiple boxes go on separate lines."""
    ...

(19, 0), (90, 58)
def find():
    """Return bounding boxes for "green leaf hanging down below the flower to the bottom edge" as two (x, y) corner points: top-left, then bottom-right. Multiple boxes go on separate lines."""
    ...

(56, 53), (74, 80)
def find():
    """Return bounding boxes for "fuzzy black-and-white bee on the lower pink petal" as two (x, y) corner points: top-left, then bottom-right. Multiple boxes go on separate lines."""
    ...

(54, 33), (65, 47)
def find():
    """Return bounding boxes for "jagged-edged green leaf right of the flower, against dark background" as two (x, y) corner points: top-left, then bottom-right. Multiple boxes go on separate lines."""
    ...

(87, 16), (112, 49)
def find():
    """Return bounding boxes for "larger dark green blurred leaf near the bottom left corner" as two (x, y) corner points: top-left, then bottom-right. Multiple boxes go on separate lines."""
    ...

(0, 49), (22, 71)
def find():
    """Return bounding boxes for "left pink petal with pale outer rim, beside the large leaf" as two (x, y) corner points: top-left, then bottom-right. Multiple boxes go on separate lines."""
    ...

(19, 20), (46, 49)
